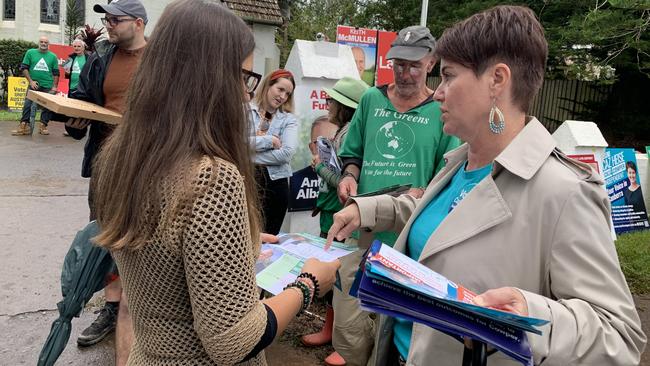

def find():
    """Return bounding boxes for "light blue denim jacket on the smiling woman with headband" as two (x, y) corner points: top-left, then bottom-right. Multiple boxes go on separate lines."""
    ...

(250, 102), (298, 180)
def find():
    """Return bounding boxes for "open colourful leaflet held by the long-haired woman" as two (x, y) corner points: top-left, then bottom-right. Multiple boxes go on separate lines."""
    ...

(255, 233), (355, 295)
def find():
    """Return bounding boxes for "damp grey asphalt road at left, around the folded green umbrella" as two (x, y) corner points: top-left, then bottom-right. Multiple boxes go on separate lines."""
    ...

(0, 122), (113, 365)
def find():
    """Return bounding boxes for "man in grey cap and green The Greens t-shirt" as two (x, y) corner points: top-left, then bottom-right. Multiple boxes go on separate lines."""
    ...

(332, 26), (460, 365)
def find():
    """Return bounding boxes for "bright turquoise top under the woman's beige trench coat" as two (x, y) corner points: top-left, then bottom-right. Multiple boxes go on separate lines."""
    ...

(393, 164), (492, 359)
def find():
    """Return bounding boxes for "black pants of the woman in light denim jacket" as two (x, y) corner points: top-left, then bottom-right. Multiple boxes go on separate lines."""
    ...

(255, 165), (289, 235)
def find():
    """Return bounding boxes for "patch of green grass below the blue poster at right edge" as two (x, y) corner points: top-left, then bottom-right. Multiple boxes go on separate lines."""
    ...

(616, 230), (650, 295)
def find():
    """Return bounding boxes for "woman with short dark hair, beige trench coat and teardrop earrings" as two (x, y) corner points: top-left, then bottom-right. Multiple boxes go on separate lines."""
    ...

(329, 6), (646, 366)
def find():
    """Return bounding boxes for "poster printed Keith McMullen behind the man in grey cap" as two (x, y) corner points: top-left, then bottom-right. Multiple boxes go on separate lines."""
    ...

(336, 25), (377, 86)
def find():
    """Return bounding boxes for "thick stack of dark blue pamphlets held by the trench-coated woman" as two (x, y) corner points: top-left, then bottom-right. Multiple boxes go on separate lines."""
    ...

(351, 241), (548, 366)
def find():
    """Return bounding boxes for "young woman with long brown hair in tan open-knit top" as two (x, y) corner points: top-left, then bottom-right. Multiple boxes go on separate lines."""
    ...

(95, 0), (338, 365)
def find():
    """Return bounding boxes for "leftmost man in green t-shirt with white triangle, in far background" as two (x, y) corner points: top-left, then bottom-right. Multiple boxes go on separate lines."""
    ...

(12, 36), (59, 136)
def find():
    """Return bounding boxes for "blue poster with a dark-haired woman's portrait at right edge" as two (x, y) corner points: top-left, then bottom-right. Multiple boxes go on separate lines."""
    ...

(603, 148), (650, 234)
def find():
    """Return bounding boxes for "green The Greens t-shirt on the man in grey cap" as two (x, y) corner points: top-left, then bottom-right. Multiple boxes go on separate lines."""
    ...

(339, 86), (460, 245)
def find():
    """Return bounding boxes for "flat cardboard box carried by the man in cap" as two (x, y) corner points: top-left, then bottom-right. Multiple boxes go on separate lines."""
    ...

(27, 90), (122, 125)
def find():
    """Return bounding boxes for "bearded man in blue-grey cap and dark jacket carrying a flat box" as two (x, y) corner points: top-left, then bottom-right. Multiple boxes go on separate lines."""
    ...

(60, 0), (148, 365)
